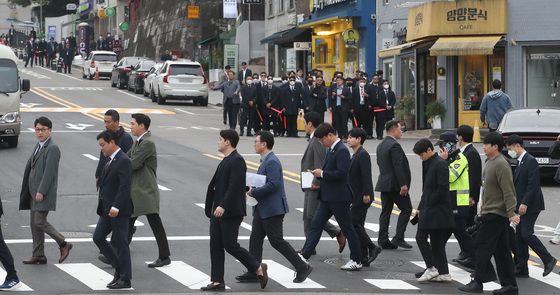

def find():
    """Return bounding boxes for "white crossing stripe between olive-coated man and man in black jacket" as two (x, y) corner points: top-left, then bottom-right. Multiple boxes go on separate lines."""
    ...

(146, 261), (230, 290)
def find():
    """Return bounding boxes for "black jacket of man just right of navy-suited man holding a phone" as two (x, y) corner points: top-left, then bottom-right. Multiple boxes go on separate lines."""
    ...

(349, 147), (373, 204)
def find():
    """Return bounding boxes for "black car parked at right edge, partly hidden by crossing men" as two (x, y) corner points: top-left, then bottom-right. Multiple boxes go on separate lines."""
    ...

(497, 108), (560, 174)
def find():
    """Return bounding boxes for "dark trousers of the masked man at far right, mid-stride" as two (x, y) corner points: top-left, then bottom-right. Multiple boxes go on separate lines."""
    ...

(515, 213), (554, 272)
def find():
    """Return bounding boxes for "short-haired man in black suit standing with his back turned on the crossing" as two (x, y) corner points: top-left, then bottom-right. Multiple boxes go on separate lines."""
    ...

(375, 120), (412, 249)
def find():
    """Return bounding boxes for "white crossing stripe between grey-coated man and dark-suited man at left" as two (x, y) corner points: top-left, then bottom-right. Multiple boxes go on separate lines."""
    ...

(55, 263), (134, 291)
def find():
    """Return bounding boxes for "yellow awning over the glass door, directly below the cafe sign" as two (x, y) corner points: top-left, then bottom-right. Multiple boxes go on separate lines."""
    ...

(430, 36), (502, 56)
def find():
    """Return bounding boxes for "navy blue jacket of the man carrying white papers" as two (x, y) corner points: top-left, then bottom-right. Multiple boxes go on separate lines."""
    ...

(252, 152), (289, 219)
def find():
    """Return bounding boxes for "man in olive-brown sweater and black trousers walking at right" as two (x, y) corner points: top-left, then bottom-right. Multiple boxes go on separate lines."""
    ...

(459, 132), (519, 295)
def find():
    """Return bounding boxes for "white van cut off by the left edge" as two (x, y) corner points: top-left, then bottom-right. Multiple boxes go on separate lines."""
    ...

(0, 45), (30, 148)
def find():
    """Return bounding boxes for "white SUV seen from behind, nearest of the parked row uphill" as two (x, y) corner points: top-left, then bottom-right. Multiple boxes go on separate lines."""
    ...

(154, 60), (208, 106)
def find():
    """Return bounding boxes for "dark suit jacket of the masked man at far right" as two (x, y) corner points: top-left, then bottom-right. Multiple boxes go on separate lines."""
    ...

(513, 153), (544, 214)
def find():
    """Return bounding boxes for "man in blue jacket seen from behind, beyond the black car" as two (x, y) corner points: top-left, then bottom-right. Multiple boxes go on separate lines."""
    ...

(480, 80), (512, 132)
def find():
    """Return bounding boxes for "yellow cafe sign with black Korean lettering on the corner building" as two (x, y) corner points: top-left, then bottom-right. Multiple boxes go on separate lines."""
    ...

(406, 0), (507, 42)
